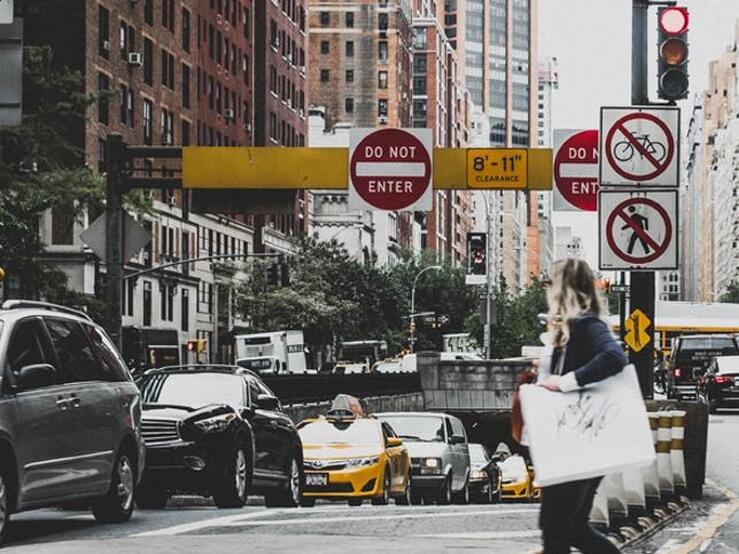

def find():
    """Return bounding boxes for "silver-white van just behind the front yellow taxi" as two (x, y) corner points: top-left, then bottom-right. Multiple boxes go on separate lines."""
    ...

(376, 412), (470, 504)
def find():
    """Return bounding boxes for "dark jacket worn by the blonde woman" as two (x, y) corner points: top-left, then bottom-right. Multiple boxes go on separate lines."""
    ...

(552, 312), (628, 387)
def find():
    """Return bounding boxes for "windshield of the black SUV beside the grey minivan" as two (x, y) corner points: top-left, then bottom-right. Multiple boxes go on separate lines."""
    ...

(142, 373), (244, 408)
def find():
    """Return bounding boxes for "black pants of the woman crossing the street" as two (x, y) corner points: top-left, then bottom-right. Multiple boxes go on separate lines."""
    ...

(539, 477), (619, 554)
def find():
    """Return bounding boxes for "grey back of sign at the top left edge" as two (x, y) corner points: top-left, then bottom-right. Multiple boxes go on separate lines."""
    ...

(0, 18), (23, 127)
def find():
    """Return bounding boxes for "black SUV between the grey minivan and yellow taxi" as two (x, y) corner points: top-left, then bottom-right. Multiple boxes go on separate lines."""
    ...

(136, 365), (304, 508)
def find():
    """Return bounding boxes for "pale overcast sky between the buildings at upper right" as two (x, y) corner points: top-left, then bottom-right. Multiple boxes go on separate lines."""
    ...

(538, 0), (739, 263)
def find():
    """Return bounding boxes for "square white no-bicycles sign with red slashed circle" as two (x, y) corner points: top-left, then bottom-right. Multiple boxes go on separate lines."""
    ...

(600, 107), (680, 187)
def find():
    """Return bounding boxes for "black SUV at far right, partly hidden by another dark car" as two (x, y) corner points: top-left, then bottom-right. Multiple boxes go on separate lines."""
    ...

(667, 335), (739, 400)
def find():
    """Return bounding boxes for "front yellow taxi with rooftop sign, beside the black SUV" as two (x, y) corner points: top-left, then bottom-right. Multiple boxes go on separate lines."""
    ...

(298, 395), (411, 507)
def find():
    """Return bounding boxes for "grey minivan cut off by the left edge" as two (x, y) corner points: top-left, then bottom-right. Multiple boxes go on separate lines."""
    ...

(0, 300), (144, 541)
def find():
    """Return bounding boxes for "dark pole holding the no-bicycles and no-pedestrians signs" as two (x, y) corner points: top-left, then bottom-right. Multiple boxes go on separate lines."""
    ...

(629, 0), (655, 398)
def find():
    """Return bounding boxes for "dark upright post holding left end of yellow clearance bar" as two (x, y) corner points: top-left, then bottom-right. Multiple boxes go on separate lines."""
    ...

(105, 133), (126, 350)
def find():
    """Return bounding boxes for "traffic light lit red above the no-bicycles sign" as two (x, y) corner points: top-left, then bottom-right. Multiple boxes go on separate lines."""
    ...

(657, 7), (690, 101)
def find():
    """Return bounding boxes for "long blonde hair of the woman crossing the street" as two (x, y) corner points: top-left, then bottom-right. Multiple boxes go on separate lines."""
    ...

(547, 258), (608, 346)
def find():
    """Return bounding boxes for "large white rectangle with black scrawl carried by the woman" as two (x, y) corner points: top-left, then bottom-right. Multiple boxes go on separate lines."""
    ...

(521, 366), (656, 487)
